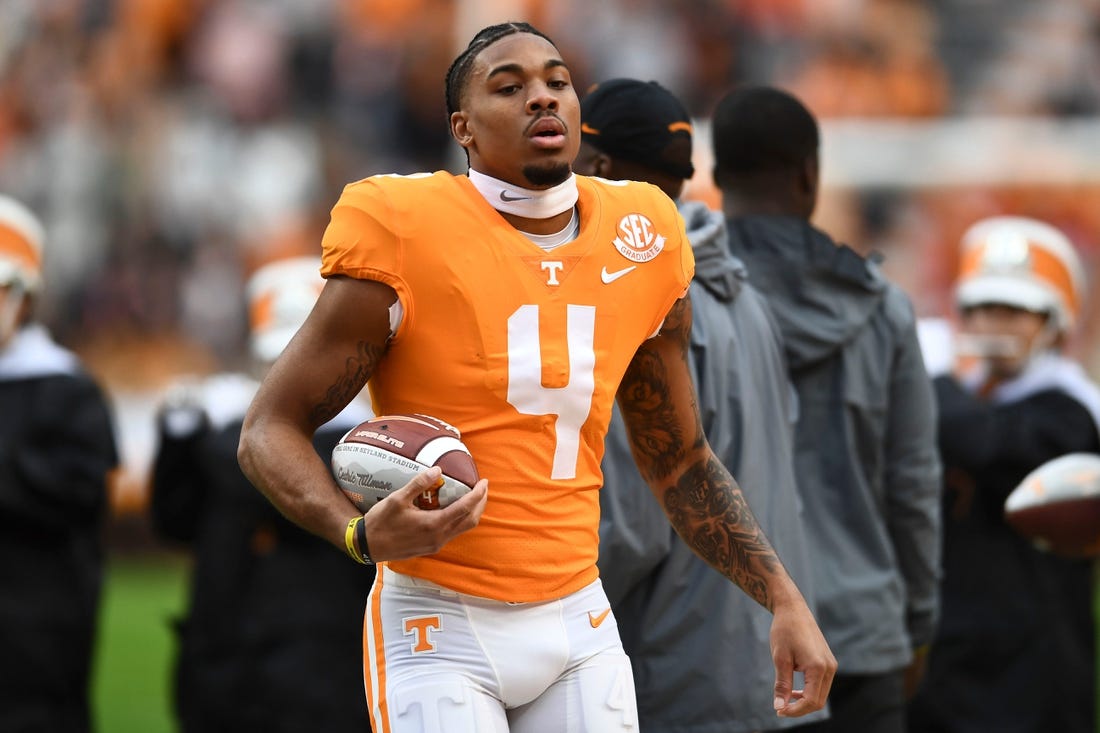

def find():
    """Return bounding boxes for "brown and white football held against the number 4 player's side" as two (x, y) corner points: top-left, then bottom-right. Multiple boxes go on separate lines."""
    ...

(332, 415), (480, 512)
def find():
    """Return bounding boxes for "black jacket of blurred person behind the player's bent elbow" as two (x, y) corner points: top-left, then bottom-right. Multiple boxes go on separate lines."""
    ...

(153, 376), (374, 733)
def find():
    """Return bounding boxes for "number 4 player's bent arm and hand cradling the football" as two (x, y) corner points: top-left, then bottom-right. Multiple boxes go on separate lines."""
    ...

(238, 277), (486, 560)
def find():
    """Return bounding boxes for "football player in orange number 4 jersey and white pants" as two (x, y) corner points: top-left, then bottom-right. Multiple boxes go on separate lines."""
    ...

(239, 23), (834, 733)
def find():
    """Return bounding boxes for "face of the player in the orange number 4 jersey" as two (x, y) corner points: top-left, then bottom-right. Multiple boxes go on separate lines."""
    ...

(451, 33), (581, 188)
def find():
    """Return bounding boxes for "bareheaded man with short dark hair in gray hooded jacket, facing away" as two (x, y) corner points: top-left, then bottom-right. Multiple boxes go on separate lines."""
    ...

(712, 87), (942, 733)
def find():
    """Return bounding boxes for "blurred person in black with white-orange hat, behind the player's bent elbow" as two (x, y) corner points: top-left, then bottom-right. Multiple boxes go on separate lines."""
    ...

(150, 256), (374, 733)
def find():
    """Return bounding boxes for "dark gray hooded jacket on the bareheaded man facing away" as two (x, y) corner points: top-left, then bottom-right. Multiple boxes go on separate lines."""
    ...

(728, 216), (941, 675)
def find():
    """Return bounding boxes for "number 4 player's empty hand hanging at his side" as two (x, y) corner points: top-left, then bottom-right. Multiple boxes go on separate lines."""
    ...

(771, 599), (836, 718)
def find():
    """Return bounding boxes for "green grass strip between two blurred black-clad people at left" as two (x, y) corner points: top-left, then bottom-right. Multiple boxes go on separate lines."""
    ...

(92, 553), (188, 733)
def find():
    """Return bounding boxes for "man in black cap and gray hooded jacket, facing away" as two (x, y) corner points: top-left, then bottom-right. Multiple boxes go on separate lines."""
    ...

(574, 79), (826, 733)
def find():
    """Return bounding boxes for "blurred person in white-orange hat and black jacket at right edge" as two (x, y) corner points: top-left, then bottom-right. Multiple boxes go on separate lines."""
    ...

(909, 216), (1100, 733)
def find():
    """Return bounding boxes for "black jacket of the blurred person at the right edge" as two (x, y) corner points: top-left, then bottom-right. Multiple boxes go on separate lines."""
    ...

(910, 358), (1100, 733)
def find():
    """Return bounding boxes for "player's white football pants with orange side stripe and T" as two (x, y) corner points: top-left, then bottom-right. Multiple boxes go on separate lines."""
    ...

(363, 566), (638, 733)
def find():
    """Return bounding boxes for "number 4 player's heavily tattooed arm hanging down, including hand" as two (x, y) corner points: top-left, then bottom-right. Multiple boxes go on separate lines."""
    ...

(618, 297), (836, 718)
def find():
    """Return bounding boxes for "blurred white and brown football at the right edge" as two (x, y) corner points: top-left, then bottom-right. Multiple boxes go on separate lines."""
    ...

(1004, 453), (1100, 557)
